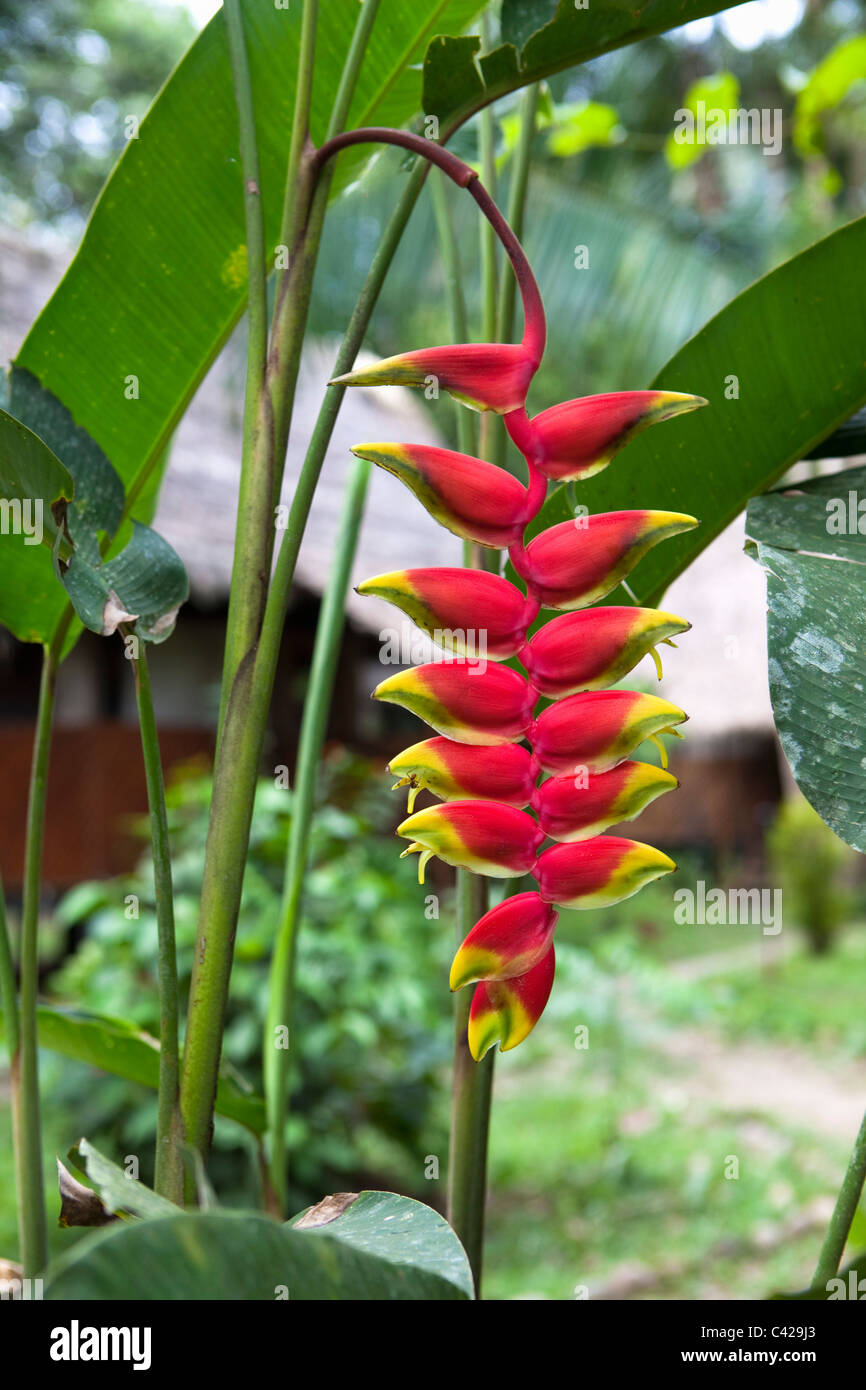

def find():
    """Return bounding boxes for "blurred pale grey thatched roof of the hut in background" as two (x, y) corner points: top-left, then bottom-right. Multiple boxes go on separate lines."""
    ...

(0, 236), (771, 741)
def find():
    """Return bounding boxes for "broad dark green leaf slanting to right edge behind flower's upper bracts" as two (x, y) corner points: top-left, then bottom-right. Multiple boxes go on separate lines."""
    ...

(517, 218), (866, 616)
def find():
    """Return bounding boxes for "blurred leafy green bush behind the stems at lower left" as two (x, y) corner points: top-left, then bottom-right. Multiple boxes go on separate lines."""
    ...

(49, 753), (452, 1207)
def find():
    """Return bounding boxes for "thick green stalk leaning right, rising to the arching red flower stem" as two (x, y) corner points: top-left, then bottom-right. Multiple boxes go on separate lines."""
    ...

(181, 154), (427, 1173)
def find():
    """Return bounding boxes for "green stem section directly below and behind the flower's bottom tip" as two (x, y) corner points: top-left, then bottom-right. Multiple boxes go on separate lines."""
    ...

(448, 870), (496, 1298)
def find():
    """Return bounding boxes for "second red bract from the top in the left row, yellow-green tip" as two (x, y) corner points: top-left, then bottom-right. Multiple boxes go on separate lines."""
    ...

(352, 443), (530, 550)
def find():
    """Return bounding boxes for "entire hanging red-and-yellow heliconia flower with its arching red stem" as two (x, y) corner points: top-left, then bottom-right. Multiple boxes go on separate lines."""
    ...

(347, 159), (697, 1059)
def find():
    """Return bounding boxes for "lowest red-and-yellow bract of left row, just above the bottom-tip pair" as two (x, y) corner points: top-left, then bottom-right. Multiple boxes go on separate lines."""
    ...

(398, 801), (545, 883)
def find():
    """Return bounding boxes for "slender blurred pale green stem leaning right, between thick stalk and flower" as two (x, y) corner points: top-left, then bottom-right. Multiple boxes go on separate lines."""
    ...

(264, 459), (370, 1211)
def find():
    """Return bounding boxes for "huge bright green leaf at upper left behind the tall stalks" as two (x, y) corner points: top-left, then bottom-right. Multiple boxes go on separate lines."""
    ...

(17, 0), (482, 542)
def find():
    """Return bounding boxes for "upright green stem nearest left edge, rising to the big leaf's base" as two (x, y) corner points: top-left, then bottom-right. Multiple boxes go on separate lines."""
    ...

(11, 639), (58, 1279)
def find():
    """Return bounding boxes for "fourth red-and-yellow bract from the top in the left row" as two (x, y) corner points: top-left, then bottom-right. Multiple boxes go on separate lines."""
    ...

(373, 659), (537, 744)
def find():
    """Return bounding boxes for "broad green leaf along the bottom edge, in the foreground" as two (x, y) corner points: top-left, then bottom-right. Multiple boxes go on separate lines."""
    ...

(44, 1193), (473, 1302)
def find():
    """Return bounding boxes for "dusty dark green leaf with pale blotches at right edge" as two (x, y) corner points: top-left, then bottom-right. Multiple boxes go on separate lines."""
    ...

(746, 468), (866, 851)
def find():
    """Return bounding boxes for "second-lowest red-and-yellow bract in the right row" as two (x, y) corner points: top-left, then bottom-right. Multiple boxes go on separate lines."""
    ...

(531, 762), (680, 842)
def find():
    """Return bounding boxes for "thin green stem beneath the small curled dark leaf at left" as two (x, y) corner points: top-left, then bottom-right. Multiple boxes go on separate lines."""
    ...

(132, 641), (183, 1205)
